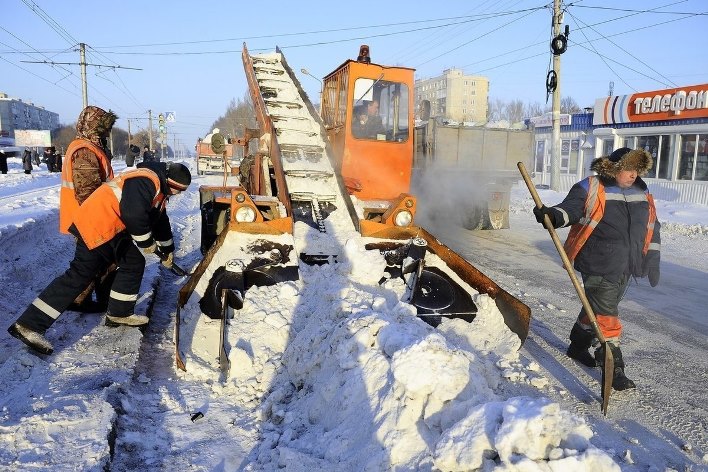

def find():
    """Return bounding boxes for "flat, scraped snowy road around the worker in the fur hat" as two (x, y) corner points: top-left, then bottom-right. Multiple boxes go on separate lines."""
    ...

(420, 189), (708, 470)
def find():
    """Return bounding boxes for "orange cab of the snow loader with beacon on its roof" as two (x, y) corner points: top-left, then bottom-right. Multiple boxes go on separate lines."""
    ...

(322, 46), (414, 201)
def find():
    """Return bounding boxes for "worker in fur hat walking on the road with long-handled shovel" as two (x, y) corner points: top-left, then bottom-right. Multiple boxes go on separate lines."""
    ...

(518, 148), (661, 414)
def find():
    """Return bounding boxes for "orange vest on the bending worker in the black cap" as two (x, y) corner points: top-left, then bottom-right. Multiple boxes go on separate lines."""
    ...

(74, 169), (167, 249)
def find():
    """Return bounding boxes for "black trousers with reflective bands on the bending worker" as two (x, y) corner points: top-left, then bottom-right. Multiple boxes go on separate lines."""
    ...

(17, 227), (145, 333)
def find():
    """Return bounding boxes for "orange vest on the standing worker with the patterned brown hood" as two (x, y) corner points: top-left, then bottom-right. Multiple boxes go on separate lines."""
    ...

(59, 139), (113, 234)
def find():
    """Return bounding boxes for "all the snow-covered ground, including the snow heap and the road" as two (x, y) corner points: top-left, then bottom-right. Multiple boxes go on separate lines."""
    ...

(0, 159), (708, 471)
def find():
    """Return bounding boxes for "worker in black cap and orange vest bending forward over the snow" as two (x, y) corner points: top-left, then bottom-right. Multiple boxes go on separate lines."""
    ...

(8, 162), (192, 354)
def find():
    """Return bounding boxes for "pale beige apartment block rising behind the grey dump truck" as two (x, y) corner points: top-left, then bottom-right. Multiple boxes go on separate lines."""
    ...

(414, 68), (489, 124)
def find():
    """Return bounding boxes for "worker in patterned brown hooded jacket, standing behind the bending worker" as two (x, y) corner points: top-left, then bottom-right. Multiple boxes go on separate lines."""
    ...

(59, 105), (118, 313)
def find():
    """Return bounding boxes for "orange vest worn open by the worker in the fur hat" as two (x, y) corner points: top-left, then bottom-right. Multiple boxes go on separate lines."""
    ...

(563, 175), (656, 264)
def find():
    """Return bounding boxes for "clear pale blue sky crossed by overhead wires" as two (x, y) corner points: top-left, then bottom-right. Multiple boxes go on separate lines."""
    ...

(0, 0), (708, 148)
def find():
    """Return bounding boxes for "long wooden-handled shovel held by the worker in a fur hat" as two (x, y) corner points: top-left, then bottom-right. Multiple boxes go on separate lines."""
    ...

(517, 162), (615, 416)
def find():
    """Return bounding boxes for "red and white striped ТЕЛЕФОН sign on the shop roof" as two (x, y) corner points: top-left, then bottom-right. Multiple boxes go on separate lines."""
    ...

(593, 84), (708, 125)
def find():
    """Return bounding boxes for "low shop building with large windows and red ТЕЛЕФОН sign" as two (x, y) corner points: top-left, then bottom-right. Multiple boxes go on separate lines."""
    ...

(529, 84), (708, 205)
